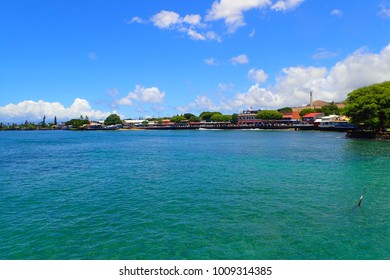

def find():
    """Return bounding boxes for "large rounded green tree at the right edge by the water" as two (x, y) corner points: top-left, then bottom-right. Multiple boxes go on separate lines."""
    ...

(345, 82), (390, 131)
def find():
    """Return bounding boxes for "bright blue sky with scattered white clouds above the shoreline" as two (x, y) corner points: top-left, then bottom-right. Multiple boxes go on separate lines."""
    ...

(0, 0), (390, 122)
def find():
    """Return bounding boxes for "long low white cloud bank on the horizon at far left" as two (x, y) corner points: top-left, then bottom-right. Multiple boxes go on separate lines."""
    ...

(0, 98), (110, 122)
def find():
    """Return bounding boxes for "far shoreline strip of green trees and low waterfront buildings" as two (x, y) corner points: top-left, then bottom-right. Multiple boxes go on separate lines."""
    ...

(0, 82), (390, 135)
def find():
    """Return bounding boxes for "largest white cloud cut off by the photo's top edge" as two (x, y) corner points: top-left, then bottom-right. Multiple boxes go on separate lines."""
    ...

(206, 0), (271, 33)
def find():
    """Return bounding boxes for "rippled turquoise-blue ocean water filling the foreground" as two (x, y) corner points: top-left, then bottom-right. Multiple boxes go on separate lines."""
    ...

(0, 131), (390, 260)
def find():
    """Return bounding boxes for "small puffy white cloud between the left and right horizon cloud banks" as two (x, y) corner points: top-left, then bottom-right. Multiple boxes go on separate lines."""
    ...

(116, 85), (165, 106)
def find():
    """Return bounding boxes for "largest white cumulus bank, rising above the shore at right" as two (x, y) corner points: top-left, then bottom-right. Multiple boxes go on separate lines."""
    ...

(181, 44), (390, 112)
